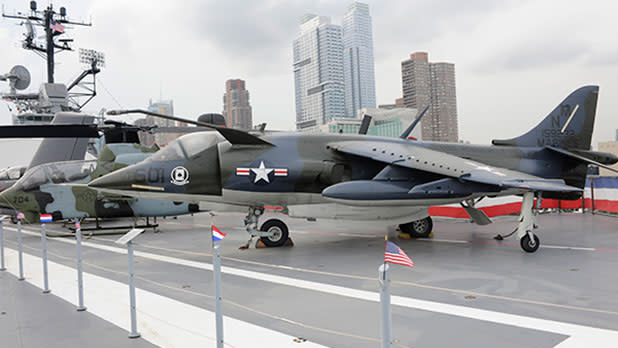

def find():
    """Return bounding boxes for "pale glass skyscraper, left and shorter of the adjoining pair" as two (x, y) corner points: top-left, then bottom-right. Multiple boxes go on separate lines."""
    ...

(293, 14), (345, 131)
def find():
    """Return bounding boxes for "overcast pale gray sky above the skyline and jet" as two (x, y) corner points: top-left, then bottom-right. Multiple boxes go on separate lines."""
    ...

(0, 0), (618, 148)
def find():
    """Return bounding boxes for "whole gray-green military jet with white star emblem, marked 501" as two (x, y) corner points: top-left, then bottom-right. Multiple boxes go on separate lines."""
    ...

(68, 86), (618, 252)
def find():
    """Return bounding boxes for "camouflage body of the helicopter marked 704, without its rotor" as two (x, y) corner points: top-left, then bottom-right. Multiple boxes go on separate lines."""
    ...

(0, 144), (199, 223)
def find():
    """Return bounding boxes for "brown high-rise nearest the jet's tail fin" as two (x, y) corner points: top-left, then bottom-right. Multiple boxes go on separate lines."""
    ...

(401, 52), (459, 142)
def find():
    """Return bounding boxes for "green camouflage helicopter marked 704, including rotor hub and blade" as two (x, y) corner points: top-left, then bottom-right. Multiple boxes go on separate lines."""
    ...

(0, 111), (224, 227)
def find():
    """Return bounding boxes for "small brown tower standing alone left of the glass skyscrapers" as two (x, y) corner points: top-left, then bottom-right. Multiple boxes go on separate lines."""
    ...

(223, 79), (253, 129)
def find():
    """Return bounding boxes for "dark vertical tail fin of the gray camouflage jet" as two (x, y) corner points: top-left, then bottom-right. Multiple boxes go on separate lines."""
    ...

(492, 86), (599, 150)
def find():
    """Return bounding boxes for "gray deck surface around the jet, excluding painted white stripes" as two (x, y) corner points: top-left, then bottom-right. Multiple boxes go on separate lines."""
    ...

(0, 213), (618, 348)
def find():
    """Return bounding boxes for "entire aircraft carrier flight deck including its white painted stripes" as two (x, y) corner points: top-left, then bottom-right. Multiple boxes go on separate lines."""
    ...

(0, 213), (618, 348)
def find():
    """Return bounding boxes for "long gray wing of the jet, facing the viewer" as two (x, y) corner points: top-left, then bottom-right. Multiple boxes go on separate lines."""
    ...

(329, 141), (581, 192)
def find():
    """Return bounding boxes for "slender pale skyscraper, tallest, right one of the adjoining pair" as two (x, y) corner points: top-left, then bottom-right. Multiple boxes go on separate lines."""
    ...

(343, 2), (376, 117)
